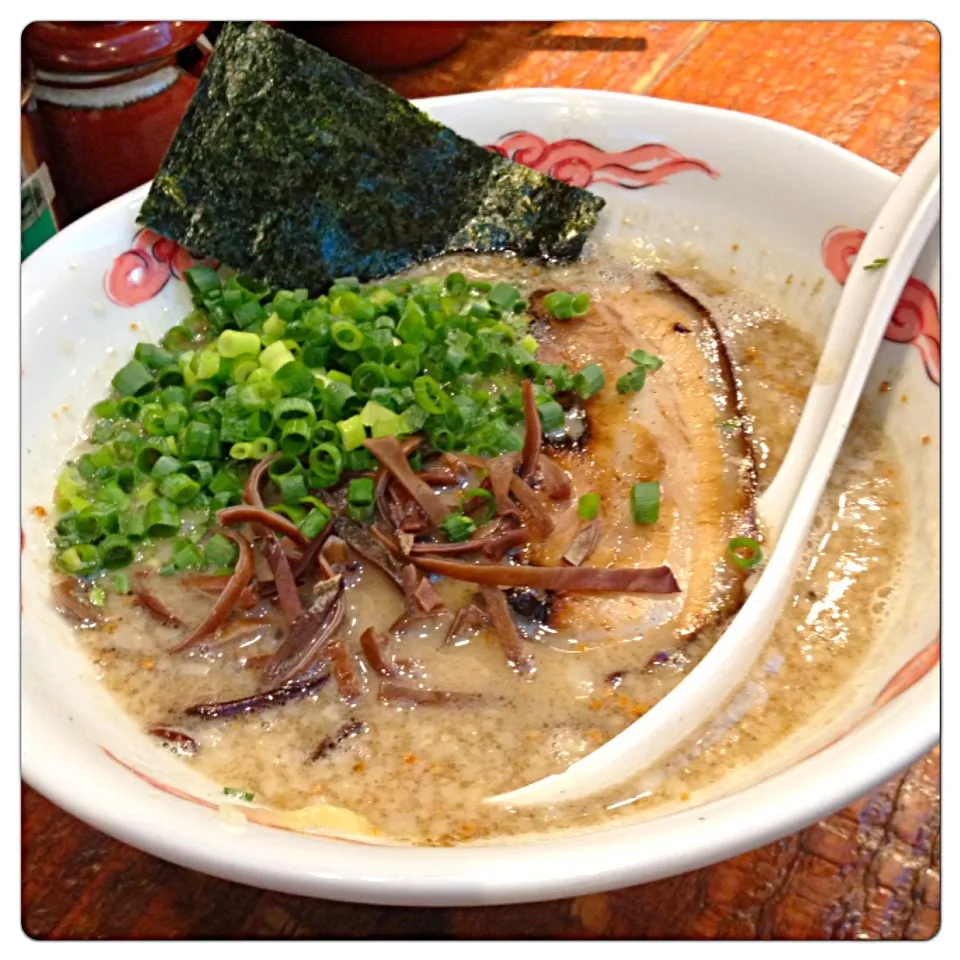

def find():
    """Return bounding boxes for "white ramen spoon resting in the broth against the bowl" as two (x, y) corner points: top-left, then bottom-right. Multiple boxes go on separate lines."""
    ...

(485, 128), (940, 807)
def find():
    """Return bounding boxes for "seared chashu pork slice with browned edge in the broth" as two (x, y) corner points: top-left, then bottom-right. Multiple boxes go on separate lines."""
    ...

(530, 275), (755, 653)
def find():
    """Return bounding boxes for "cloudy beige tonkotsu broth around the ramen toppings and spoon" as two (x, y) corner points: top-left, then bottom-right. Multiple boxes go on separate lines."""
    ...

(56, 244), (906, 845)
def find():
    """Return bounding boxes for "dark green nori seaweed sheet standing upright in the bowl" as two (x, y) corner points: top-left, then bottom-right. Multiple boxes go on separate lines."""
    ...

(138, 22), (603, 292)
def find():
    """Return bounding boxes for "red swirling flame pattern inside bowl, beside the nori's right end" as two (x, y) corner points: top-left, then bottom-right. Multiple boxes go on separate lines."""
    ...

(487, 131), (720, 190)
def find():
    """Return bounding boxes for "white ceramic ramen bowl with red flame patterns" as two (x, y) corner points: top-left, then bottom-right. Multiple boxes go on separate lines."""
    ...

(22, 90), (940, 905)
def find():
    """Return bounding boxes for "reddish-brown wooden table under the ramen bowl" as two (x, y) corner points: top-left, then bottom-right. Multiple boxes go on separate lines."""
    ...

(23, 22), (940, 939)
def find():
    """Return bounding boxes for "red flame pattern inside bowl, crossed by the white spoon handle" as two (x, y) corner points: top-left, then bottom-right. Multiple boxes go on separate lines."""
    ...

(821, 227), (940, 386)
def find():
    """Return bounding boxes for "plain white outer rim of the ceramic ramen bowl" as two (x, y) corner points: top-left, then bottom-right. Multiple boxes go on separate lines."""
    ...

(21, 87), (940, 906)
